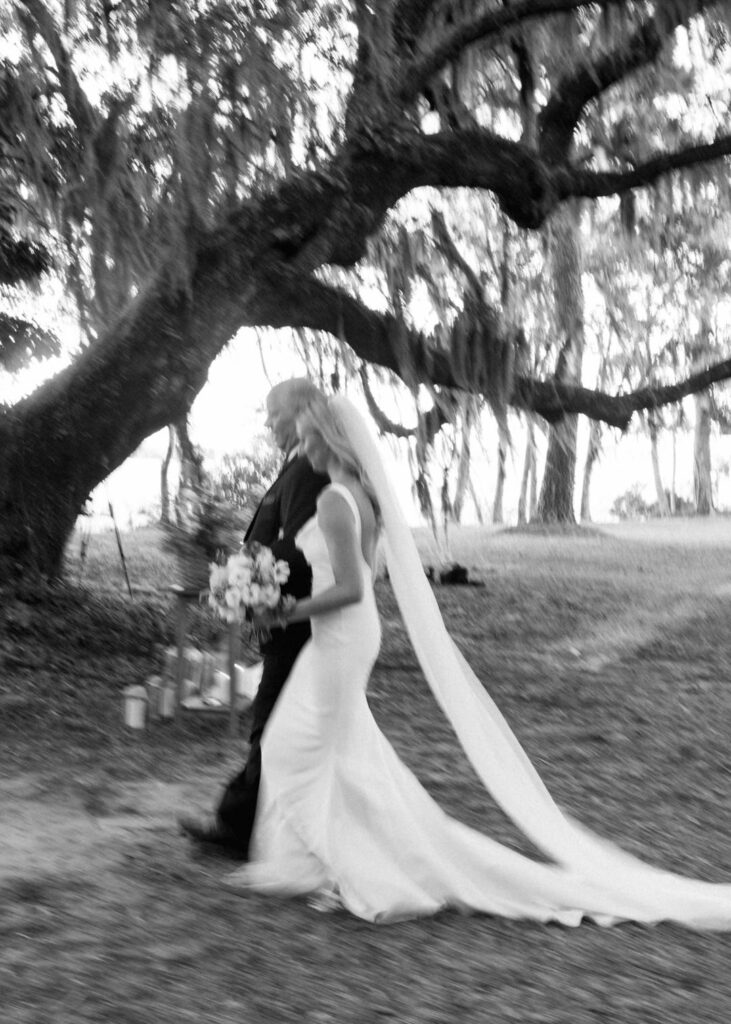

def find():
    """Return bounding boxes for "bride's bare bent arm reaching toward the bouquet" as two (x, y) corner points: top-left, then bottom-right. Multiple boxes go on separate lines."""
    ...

(287, 490), (363, 623)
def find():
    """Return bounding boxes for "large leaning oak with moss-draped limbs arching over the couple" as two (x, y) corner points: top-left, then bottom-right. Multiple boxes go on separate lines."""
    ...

(0, 0), (731, 574)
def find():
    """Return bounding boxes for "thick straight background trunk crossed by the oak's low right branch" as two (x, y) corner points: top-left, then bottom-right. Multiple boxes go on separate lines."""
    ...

(538, 203), (584, 522)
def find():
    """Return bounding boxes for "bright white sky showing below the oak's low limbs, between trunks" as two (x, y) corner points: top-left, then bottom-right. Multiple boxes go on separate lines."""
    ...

(5, 313), (731, 528)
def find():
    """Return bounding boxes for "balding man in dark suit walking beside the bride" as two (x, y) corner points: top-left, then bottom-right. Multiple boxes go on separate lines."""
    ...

(179, 378), (330, 860)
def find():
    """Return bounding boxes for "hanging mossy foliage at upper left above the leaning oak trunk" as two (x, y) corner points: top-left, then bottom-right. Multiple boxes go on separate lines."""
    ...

(0, 0), (352, 337)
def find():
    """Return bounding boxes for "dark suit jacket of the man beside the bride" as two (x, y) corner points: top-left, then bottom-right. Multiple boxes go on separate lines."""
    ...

(245, 456), (330, 653)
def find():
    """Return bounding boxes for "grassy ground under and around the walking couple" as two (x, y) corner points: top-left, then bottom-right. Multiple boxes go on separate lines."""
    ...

(0, 519), (731, 1024)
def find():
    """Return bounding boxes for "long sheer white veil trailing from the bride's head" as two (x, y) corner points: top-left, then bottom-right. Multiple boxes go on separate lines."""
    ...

(330, 395), (731, 929)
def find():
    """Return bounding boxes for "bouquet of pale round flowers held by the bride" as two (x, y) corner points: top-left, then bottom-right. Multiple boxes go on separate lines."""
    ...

(208, 543), (292, 623)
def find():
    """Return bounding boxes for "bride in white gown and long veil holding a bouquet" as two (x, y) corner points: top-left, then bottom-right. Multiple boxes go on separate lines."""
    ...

(226, 396), (731, 930)
